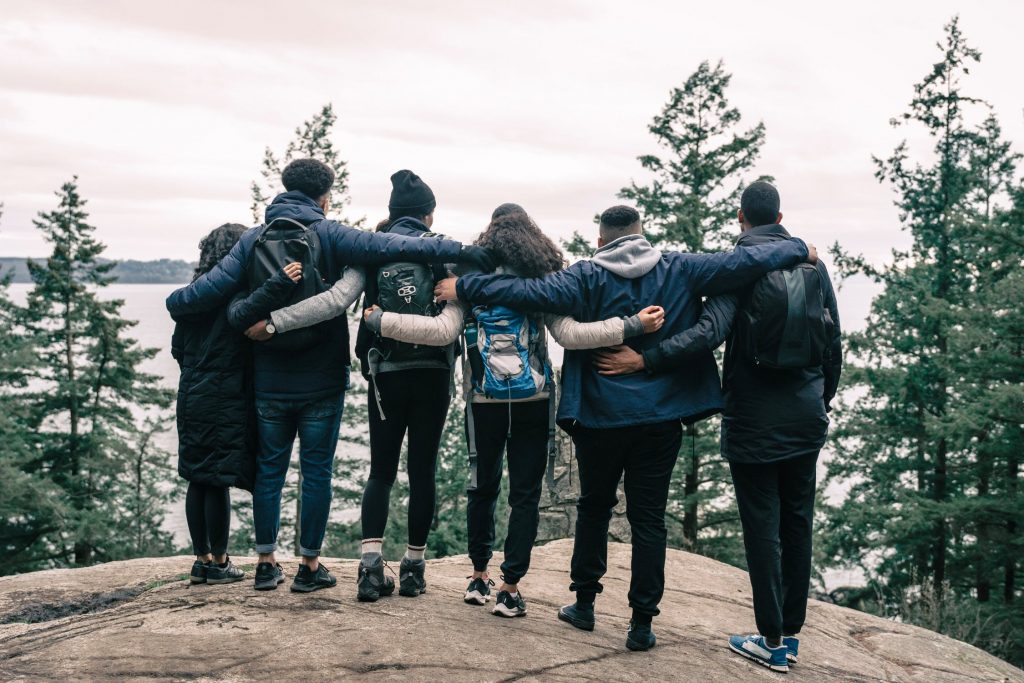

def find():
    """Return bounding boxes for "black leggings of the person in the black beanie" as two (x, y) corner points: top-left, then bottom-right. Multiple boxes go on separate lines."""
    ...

(362, 369), (452, 547)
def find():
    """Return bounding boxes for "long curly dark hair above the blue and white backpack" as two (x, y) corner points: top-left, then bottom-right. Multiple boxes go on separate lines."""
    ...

(474, 205), (565, 278)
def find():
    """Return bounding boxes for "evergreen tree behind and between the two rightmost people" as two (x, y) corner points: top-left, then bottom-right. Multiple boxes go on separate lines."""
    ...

(565, 61), (770, 566)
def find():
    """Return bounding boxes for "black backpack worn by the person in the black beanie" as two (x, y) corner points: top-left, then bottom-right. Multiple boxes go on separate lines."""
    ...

(375, 232), (451, 362)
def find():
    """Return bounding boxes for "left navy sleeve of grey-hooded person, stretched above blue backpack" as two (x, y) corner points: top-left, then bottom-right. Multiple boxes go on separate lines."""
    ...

(456, 261), (587, 315)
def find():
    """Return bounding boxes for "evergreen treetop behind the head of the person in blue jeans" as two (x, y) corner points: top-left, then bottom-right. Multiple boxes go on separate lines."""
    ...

(250, 102), (365, 227)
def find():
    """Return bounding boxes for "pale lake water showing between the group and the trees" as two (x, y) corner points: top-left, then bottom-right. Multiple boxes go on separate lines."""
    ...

(10, 281), (877, 589)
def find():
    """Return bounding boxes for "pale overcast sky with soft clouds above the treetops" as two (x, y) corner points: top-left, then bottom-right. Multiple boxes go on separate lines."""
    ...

(0, 0), (1024, 327)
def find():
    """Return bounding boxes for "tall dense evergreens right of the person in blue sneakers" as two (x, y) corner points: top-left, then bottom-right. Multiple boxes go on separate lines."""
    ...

(822, 18), (1024, 660)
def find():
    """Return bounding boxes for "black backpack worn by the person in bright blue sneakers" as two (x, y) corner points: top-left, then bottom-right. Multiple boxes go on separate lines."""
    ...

(737, 263), (833, 370)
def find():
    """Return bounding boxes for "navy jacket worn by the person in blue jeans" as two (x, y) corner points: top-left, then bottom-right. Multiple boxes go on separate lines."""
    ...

(167, 191), (462, 400)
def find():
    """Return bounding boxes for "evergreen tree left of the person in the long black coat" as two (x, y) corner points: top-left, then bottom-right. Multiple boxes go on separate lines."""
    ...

(24, 178), (171, 565)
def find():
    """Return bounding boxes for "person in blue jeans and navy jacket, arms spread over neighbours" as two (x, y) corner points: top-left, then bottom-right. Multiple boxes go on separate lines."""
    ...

(167, 159), (494, 592)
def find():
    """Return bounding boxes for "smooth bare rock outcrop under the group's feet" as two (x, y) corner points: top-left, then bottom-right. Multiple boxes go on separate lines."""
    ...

(0, 541), (1024, 683)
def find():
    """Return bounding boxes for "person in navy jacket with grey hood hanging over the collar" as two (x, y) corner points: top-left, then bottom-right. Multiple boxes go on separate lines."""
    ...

(436, 206), (816, 650)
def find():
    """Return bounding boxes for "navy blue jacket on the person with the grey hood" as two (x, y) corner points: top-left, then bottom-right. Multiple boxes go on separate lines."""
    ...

(457, 236), (807, 431)
